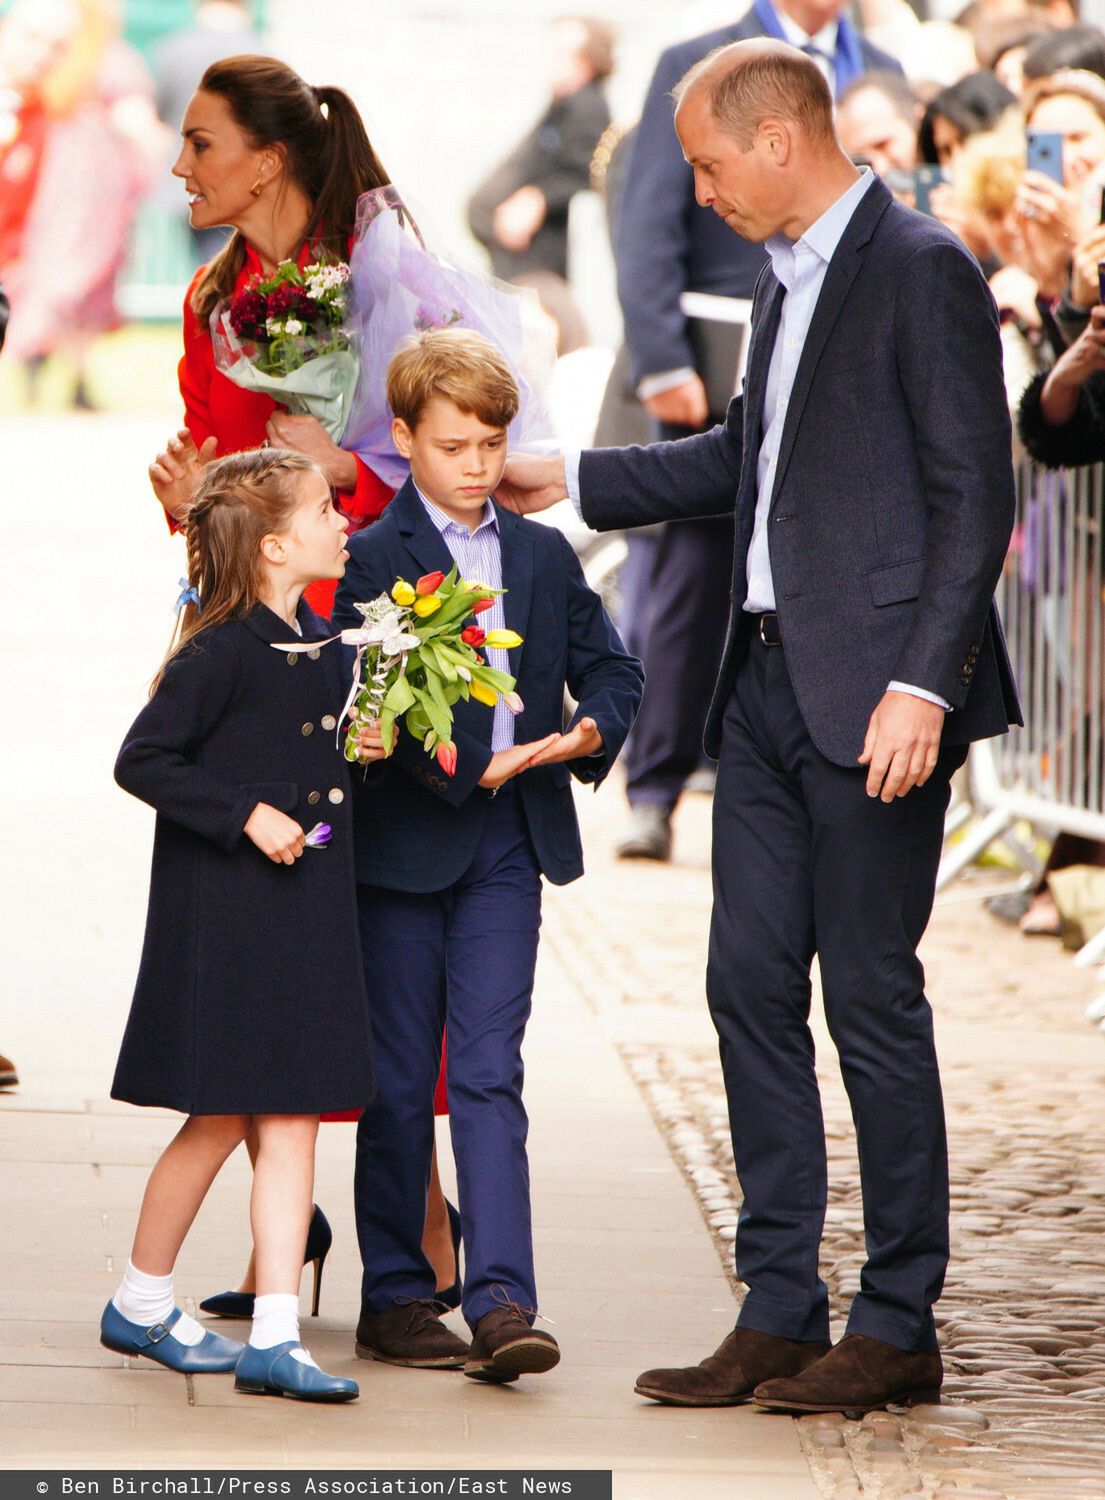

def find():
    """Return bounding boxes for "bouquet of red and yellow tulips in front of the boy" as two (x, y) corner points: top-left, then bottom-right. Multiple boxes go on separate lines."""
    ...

(342, 566), (522, 776)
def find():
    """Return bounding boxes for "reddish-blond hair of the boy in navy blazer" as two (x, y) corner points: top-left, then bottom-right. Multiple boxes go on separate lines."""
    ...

(387, 329), (520, 432)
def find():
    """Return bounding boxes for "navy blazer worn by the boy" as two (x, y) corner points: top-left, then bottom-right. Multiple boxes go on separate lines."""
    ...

(333, 480), (645, 891)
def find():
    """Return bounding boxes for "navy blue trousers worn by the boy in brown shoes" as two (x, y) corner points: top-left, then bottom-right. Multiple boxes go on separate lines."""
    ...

(354, 783), (541, 1328)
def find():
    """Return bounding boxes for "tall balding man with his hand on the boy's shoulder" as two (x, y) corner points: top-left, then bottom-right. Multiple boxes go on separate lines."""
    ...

(501, 41), (1020, 1412)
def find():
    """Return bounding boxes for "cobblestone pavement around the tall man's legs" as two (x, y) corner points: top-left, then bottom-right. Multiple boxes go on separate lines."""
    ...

(549, 801), (1105, 1500)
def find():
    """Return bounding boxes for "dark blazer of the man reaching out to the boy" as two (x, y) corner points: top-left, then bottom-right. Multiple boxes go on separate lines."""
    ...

(580, 172), (1021, 767)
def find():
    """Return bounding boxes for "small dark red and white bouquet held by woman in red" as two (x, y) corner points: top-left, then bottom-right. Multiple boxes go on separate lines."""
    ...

(211, 261), (360, 443)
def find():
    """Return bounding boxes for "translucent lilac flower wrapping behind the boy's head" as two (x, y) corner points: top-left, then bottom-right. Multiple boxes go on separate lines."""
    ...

(342, 186), (556, 489)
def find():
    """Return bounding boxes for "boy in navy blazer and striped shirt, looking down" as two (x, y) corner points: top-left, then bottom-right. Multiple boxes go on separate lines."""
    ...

(334, 329), (643, 1382)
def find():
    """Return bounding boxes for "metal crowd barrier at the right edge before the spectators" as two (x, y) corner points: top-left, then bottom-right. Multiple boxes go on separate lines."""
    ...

(937, 462), (1105, 965)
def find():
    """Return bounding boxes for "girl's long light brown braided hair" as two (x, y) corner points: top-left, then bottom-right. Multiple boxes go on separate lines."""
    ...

(150, 449), (324, 698)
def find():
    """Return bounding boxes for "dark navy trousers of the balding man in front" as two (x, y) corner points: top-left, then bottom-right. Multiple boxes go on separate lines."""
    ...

(706, 624), (966, 1350)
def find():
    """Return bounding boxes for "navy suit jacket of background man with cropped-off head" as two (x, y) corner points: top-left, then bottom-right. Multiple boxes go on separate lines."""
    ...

(615, 9), (901, 387)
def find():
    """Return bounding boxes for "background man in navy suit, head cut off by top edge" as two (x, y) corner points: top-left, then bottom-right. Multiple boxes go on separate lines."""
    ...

(615, 0), (901, 858)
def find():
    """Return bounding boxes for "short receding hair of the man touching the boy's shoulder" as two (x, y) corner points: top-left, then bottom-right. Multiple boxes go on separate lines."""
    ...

(672, 42), (837, 152)
